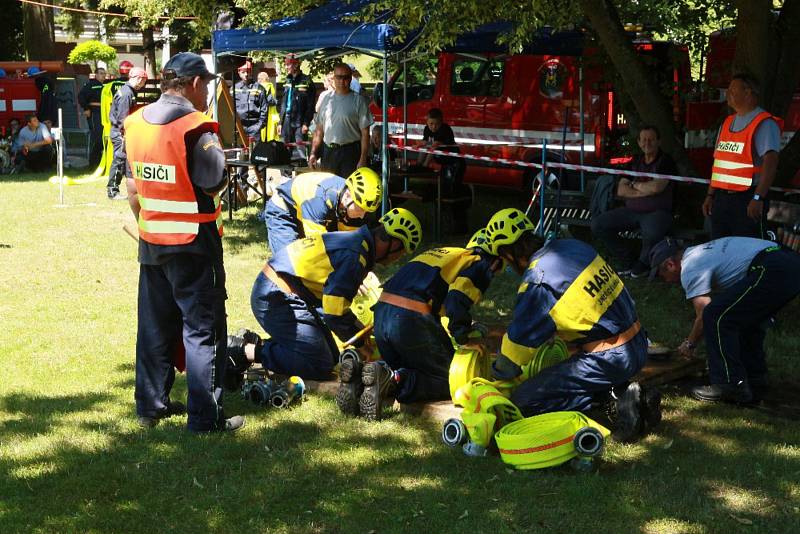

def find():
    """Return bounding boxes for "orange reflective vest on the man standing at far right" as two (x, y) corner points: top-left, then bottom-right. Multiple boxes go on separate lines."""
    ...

(711, 111), (780, 191)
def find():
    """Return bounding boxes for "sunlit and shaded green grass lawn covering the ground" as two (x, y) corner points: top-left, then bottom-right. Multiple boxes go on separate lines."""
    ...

(0, 175), (800, 533)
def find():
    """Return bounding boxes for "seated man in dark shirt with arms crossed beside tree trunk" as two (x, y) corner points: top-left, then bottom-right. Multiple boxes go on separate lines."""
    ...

(592, 125), (677, 278)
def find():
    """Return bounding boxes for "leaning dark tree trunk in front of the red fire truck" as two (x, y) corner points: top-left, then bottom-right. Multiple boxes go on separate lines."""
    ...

(578, 0), (692, 173)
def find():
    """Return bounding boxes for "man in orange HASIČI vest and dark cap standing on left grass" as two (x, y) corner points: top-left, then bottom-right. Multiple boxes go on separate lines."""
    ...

(125, 52), (244, 432)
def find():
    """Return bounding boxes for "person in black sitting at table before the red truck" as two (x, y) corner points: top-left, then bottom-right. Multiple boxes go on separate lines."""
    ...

(422, 108), (471, 234)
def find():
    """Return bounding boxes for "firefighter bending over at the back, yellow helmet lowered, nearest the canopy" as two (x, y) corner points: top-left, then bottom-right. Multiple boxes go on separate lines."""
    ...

(264, 167), (383, 254)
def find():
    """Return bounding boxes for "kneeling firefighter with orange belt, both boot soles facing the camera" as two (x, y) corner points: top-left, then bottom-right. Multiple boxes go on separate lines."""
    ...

(336, 230), (502, 419)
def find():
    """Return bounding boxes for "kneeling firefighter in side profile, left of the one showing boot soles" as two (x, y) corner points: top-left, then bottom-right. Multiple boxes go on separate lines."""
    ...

(226, 208), (422, 384)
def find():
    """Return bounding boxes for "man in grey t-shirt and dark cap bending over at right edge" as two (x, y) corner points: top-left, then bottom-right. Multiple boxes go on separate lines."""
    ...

(650, 237), (800, 404)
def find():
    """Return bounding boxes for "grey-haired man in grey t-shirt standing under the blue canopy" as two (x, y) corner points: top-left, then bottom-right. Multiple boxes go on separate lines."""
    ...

(308, 63), (374, 176)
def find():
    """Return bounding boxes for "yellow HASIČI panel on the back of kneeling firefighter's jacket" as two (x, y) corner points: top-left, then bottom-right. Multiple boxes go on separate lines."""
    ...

(552, 255), (625, 344)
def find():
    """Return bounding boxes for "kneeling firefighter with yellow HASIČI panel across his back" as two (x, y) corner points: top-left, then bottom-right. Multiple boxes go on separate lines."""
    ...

(486, 209), (661, 442)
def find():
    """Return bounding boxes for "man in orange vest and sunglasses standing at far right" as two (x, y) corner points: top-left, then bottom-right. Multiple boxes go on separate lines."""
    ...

(703, 74), (781, 239)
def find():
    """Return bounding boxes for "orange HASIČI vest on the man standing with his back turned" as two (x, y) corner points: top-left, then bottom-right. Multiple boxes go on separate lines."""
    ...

(125, 109), (222, 245)
